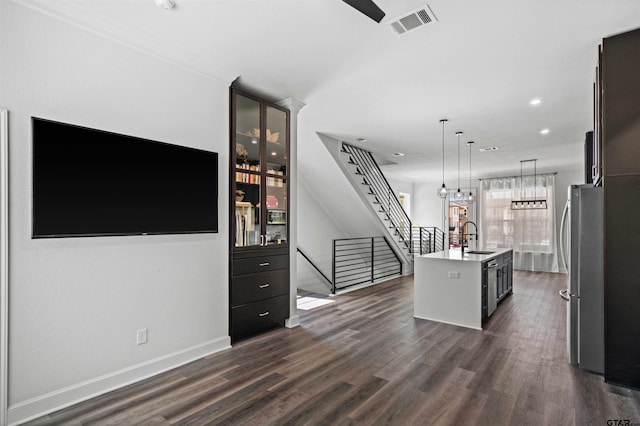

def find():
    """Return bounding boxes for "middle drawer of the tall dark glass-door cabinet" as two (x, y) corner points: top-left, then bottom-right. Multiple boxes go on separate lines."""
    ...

(231, 269), (289, 306)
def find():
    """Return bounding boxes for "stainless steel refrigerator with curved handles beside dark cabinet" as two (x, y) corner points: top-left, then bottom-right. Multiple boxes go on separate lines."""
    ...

(560, 185), (604, 373)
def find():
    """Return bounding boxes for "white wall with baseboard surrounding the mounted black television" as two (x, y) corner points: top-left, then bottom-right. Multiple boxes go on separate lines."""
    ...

(0, 1), (229, 422)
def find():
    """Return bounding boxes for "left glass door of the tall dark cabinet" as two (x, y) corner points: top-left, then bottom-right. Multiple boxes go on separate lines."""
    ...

(234, 94), (264, 247)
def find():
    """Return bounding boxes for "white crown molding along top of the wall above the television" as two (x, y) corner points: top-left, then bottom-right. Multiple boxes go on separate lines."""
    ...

(17, 0), (237, 85)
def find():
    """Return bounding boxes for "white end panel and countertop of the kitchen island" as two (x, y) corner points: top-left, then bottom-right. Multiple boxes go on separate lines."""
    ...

(413, 249), (512, 330)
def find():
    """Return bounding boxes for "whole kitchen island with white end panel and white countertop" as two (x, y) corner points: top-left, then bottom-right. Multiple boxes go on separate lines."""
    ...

(413, 249), (513, 330)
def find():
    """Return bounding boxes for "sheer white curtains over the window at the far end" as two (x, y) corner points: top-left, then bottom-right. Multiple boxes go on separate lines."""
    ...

(479, 174), (558, 272)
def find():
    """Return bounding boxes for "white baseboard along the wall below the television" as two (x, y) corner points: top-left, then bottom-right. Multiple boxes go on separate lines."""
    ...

(8, 337), (231, 425)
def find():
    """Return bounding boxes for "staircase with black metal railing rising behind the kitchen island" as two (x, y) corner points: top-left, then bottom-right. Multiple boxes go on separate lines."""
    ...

(334, 142), (444, 269)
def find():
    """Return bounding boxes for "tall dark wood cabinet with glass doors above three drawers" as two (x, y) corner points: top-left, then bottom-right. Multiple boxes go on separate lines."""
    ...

(229, 88), (290, 342)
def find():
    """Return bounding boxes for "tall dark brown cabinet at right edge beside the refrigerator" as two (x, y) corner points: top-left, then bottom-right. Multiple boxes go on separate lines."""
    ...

(599, 25), (640, 389)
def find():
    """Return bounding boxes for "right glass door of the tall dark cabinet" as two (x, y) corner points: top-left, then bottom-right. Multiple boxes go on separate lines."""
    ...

(265, 106), (288, 245)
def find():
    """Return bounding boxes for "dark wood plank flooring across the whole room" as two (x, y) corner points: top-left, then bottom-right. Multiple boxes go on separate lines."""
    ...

(29, 271), (640, 425)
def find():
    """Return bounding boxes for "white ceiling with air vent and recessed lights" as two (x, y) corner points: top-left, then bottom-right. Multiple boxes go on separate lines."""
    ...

(22, 0), (640, 180)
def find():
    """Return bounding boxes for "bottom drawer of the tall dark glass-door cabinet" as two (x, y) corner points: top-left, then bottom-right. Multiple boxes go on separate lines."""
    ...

(231, 295), (289, 341)
